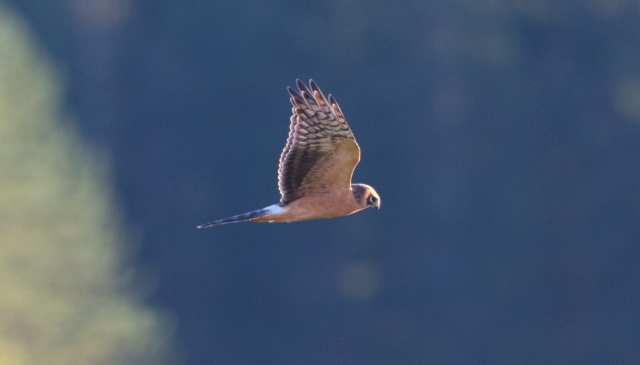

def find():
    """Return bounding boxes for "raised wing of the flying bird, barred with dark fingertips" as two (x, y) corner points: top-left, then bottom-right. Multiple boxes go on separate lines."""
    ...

(278, 80), (360, 204)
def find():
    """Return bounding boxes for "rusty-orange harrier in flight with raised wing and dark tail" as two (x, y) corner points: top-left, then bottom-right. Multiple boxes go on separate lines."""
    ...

(197, 80), (380, 228)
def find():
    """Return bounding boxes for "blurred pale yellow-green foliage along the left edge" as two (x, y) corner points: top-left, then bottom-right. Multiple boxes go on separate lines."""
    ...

(0, 5), (168, 365)
